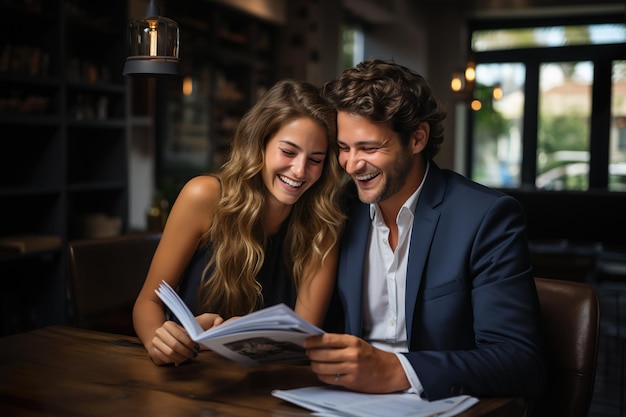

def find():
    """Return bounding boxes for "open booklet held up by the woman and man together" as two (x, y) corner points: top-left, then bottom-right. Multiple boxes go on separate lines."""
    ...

(155, 281), (324, 366)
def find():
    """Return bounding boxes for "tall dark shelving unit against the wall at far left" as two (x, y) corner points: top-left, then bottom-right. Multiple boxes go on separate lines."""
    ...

(0, 0), (128, 334)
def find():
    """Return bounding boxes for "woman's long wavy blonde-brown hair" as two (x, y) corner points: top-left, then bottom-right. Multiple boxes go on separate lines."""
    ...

(199, 80), (344, 318)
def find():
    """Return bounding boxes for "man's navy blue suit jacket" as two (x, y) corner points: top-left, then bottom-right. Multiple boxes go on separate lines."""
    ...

(337, 162), (545, 400)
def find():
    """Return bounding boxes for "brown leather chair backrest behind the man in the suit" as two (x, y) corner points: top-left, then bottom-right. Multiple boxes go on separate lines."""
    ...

(531, 278), (600, 417)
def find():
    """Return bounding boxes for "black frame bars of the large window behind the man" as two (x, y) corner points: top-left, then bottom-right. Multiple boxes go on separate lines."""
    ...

(465, 14), (626, 193)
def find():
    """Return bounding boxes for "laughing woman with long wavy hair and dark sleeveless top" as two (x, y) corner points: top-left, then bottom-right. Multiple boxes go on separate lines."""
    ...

(133, 80), (344, 365)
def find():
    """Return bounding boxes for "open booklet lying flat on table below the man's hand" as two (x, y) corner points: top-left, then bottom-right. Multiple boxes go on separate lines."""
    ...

(272, 386), (478, 417)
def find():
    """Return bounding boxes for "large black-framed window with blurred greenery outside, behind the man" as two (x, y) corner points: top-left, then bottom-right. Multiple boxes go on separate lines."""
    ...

(466, 16), (626, 191)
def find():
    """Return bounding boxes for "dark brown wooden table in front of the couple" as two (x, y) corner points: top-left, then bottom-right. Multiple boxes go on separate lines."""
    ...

(0, 326), (521, 417)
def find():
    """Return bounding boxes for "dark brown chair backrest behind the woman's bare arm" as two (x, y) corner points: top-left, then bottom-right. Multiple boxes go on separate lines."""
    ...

(68, 233), (161, 335)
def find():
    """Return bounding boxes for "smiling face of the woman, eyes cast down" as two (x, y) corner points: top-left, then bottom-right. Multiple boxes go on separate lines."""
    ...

(262, 118), (328, 205)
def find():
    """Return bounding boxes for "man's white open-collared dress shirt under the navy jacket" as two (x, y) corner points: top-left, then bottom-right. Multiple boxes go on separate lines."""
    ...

(363, 162), (428, 393)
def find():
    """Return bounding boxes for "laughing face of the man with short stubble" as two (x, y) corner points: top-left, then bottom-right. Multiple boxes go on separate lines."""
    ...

(337, 111), (421, 204)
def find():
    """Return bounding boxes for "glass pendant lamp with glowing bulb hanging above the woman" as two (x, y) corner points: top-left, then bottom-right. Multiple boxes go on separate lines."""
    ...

(122, 0), (180, 76)
